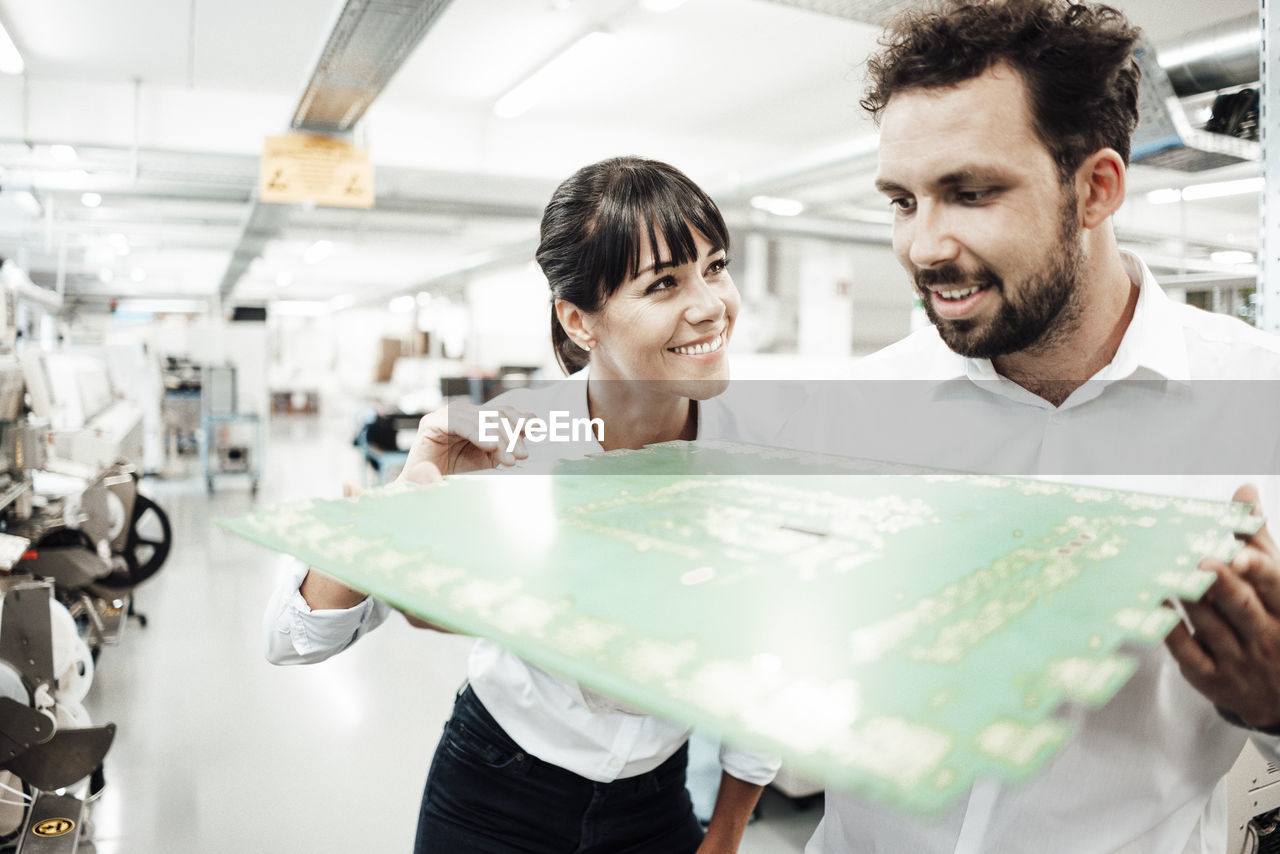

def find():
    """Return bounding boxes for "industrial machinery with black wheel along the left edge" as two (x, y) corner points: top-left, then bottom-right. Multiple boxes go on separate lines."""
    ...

(0, 262), (172, 854)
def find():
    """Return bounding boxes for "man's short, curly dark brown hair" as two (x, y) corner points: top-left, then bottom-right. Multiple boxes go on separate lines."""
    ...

(861, 0), (1142, 182)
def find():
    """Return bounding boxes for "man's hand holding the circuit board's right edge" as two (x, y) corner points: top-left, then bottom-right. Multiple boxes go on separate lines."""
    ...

(1165, 485), (1280, 730)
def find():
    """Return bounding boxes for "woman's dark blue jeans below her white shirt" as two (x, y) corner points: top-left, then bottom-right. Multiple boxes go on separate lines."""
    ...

(413, 686), (703, 854)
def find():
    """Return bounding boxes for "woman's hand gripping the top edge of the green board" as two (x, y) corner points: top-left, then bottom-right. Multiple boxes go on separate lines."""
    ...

(396, 403), (531, 483)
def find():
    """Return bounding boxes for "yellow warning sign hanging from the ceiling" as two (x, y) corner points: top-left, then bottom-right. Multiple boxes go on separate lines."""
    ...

(257, 133), (374, 207)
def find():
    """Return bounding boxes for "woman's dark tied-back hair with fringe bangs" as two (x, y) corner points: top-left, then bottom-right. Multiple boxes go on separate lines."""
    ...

(535, 157), (728, 374)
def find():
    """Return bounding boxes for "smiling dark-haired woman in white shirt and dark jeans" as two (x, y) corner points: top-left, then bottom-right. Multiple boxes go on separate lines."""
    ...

(268, 157), (780, 854)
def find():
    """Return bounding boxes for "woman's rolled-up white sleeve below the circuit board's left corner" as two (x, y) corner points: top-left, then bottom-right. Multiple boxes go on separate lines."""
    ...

(262, 563), (390, 665)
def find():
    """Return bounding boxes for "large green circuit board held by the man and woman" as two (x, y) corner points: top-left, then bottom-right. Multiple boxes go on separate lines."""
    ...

(220, 442), (1261, 813)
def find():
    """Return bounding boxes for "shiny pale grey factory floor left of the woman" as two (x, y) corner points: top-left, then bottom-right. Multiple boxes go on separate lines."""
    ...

(81, 415), (822, 854)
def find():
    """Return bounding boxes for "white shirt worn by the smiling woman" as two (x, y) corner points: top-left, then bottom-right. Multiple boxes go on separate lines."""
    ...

(266, 370), (783, 785)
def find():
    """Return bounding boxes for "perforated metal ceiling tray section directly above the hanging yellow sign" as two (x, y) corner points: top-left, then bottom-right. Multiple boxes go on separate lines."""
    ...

(292, 0), (451, 134)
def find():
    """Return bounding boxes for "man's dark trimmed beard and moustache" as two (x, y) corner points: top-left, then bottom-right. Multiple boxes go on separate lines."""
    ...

(915, 192), (1082, 359)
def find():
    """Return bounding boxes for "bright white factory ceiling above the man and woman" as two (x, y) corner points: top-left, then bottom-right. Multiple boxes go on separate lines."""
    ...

(0, 0), (1257, 316)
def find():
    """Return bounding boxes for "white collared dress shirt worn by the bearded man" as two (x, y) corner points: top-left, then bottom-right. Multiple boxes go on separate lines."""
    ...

(804, 254), (1280, 854)
